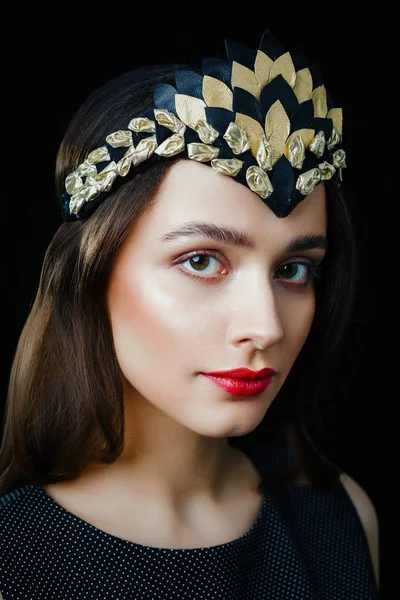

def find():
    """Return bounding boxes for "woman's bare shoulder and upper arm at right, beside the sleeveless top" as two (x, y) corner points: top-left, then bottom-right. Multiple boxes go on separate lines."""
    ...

(340, 473), (379, 587)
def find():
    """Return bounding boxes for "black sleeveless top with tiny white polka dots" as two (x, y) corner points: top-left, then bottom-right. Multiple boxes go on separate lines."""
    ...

(0, 448), (379, 600)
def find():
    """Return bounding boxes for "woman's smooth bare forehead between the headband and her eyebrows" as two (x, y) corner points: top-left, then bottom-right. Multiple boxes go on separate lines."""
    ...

(131, 160), (326, 245)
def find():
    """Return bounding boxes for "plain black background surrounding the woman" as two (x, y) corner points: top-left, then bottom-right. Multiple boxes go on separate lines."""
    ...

(1, 2), (400, 600)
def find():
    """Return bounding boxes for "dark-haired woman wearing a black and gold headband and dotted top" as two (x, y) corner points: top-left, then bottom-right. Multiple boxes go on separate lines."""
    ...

(0, 30), (378, 599)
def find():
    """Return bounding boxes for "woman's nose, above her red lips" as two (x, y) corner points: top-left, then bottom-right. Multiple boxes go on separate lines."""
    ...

(229, 274), (284, 350)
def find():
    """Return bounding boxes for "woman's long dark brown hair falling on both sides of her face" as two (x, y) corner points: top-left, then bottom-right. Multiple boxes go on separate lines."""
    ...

(0, 65), (356, 494)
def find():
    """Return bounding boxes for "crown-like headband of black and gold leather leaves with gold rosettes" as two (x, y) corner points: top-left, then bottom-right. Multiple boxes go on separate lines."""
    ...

(63, 29), (346, 221)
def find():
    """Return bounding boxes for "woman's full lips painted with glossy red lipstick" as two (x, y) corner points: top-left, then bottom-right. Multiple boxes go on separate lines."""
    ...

(202, 368), (276, 397)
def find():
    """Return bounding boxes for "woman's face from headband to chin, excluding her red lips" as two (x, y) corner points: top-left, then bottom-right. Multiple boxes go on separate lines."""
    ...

(107, 160), (327, 437)
